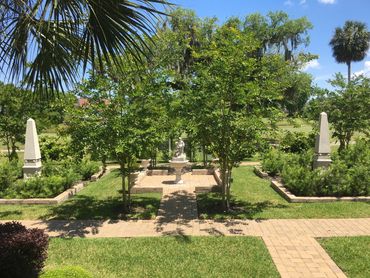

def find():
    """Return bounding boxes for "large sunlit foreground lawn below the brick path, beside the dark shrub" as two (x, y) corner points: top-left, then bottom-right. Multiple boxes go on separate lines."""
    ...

(45, 237), (279, 278)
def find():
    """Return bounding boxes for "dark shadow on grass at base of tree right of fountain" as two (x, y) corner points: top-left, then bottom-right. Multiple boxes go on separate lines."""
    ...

(197, 192), (287, 220)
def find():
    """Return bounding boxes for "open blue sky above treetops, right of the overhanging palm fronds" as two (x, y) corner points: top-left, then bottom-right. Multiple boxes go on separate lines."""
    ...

(172, 0), (370, 87)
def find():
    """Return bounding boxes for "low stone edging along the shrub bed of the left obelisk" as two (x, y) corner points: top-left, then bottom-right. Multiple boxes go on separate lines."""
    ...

(0, 168), (105, 205)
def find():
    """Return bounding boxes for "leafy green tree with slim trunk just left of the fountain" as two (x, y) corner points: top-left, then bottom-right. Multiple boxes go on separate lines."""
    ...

(65, 58), (166, 212)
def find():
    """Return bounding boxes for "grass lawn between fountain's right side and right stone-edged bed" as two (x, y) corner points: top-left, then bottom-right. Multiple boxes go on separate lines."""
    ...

(197, 167), (370, 219)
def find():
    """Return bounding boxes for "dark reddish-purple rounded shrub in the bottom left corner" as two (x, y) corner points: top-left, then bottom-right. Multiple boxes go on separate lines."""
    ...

(0, 222), (48, 278)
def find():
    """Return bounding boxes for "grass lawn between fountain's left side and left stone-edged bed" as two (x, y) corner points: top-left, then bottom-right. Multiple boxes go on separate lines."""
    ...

(0, 171), (161, 220)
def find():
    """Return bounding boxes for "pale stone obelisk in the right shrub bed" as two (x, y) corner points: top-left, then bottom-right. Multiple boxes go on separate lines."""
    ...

(313, 112), (331, 169)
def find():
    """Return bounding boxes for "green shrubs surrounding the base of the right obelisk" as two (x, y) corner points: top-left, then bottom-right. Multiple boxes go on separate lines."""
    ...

(262, 140), (370, 197)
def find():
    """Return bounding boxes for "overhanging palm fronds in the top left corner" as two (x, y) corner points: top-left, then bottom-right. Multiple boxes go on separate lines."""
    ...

(0, 0), (169, 97)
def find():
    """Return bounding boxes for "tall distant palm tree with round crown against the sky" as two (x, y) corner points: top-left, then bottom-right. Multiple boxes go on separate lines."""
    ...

(330, 20), (370, 83)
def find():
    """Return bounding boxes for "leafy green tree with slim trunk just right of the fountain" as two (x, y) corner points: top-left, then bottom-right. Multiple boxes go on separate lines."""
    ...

(192, 20), (287, 209)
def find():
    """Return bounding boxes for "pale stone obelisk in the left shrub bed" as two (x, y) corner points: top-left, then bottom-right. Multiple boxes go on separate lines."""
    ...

(23, 119), (41, 178)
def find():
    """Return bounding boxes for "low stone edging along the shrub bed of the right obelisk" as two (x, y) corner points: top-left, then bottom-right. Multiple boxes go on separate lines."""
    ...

(254, 166), (370, 203)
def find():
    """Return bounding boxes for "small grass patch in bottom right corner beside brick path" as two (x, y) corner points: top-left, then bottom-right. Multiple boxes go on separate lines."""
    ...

(319, 236), (370, 278)
